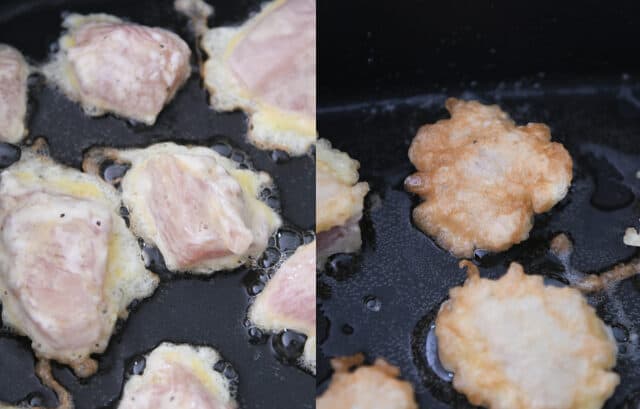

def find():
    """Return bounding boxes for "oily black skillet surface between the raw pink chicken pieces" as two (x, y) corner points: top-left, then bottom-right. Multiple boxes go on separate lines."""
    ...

(0, 0), (315, 409)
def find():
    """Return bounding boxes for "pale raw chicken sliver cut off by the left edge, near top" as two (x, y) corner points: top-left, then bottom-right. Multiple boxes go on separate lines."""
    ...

(0, 44), (29, 143)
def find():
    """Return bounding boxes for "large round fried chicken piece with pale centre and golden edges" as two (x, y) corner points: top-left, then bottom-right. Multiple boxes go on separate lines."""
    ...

(436, 262), (620, 409)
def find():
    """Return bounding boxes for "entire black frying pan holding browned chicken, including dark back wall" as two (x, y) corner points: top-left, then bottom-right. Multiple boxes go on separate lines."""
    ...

(317, 0), (640, 409)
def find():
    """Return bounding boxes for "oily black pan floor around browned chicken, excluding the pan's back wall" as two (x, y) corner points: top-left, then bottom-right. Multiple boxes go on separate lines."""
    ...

(318, 80), (640, 409)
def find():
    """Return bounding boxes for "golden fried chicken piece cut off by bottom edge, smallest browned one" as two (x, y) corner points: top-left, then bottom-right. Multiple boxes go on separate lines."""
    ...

(316, 354), (418, 409)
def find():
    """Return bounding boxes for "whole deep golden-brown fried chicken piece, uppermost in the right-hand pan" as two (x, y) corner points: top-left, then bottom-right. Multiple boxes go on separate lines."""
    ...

(405, 98), (573, 257)
